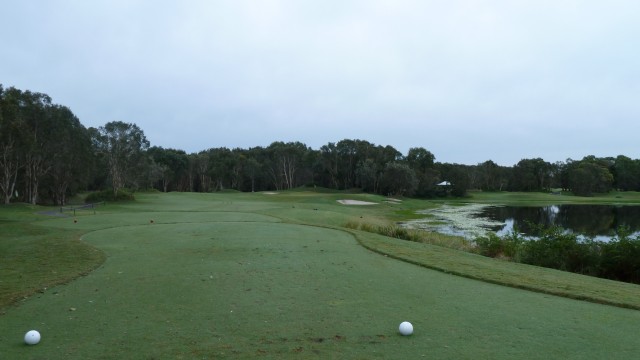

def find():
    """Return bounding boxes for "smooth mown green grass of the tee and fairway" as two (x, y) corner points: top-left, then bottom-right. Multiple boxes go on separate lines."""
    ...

(0, 192), (640, 359)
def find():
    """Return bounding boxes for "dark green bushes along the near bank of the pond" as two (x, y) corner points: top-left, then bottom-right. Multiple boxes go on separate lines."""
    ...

(474, 226), (640, 284)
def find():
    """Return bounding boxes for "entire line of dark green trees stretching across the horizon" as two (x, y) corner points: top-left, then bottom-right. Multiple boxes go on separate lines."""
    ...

(0, 84), (640, 205)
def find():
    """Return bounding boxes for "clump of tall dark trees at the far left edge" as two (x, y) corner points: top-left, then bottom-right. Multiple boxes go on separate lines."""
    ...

(0, 85), (92, 204)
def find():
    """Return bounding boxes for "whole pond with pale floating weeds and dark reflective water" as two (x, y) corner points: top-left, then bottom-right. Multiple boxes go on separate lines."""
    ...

(405, 204), (640, 241)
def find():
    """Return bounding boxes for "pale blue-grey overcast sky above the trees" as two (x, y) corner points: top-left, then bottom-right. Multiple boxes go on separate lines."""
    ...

(0, 0), (640, 166)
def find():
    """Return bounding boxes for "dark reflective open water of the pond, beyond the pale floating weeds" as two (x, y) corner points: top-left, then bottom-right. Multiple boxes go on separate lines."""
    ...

(475, 205), (640, 240)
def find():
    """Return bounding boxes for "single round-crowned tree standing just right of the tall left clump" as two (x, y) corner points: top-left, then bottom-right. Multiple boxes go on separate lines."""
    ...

(92, 121), (149, 197)
